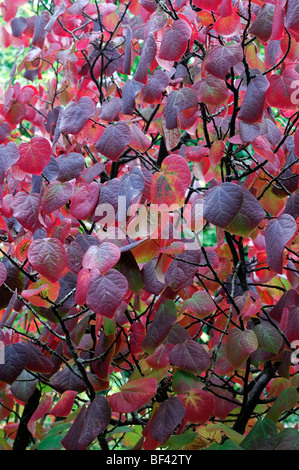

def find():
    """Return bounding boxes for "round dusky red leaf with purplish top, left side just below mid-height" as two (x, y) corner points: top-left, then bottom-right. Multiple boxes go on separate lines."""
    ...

(28, 238), (67, 282)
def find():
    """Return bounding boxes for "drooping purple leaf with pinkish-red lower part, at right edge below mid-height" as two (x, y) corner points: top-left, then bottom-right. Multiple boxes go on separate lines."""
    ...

(265, 214), (297, 274)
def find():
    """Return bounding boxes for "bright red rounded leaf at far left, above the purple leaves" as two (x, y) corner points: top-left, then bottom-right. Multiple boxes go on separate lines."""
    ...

(18, 137), (52, 175)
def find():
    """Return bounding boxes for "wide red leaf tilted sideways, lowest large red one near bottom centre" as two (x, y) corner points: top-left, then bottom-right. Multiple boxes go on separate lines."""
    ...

(108, 378), (157, 413)
